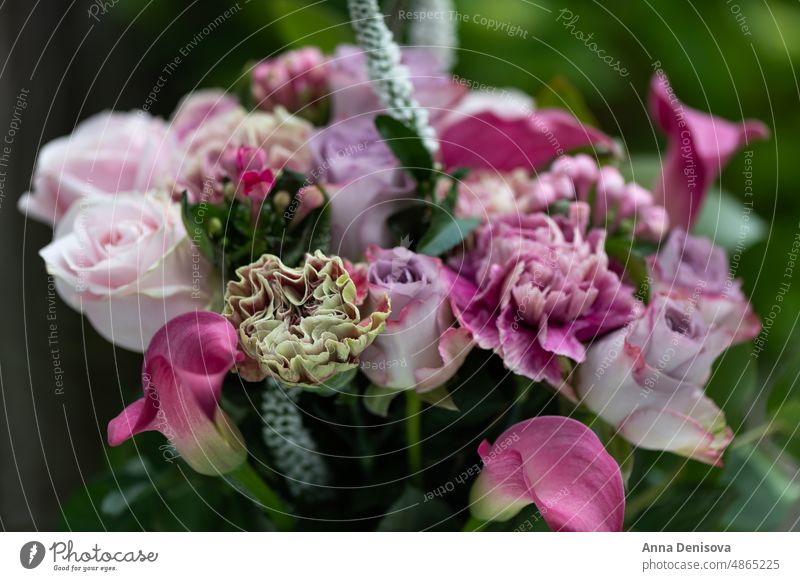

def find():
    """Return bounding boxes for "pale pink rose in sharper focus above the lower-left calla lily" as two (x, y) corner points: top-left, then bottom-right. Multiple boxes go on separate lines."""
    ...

(40, 193), (213, 352)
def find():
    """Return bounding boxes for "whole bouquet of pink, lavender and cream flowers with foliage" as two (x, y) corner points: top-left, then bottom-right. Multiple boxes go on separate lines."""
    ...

(20, 0), (767, 531)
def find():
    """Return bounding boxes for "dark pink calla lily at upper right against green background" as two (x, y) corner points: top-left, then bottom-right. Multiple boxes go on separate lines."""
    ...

(650, 74), (769, 230)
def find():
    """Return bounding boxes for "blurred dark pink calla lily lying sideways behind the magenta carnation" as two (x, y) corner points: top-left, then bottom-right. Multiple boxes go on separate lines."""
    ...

(440, 109), (615, 171)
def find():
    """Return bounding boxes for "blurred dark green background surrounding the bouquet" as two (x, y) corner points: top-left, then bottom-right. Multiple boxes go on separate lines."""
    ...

(0, 0), (800, 530)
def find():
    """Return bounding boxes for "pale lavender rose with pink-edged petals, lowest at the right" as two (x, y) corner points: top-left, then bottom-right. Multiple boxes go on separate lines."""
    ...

(575, 295), (733, 465)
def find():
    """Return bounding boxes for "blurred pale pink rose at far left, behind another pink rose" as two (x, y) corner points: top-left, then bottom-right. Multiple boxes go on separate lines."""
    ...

(19, 111), (174, 224)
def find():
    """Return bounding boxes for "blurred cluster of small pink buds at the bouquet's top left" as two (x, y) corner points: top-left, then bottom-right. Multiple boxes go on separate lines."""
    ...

(251, 47), (329, 124)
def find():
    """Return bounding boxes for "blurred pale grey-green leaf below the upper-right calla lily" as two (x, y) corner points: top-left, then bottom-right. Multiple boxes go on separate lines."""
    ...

(693, 188), (768, 254)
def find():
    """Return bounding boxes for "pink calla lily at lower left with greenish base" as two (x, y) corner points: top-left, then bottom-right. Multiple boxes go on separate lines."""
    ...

(108, 312), (247, 475)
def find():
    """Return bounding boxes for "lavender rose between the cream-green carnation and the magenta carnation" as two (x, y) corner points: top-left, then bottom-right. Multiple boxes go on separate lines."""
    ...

(361, 246), (472, 393)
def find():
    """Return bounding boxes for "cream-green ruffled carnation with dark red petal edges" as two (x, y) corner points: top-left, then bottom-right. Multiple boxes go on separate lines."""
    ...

(223, 251), (390, 386)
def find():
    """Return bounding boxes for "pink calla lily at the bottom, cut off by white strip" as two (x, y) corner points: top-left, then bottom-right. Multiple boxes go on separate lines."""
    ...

(470, 416), (625, 531)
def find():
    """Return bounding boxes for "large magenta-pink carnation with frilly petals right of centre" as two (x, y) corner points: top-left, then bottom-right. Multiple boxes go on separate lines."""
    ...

(451, 204), (635, 386)
